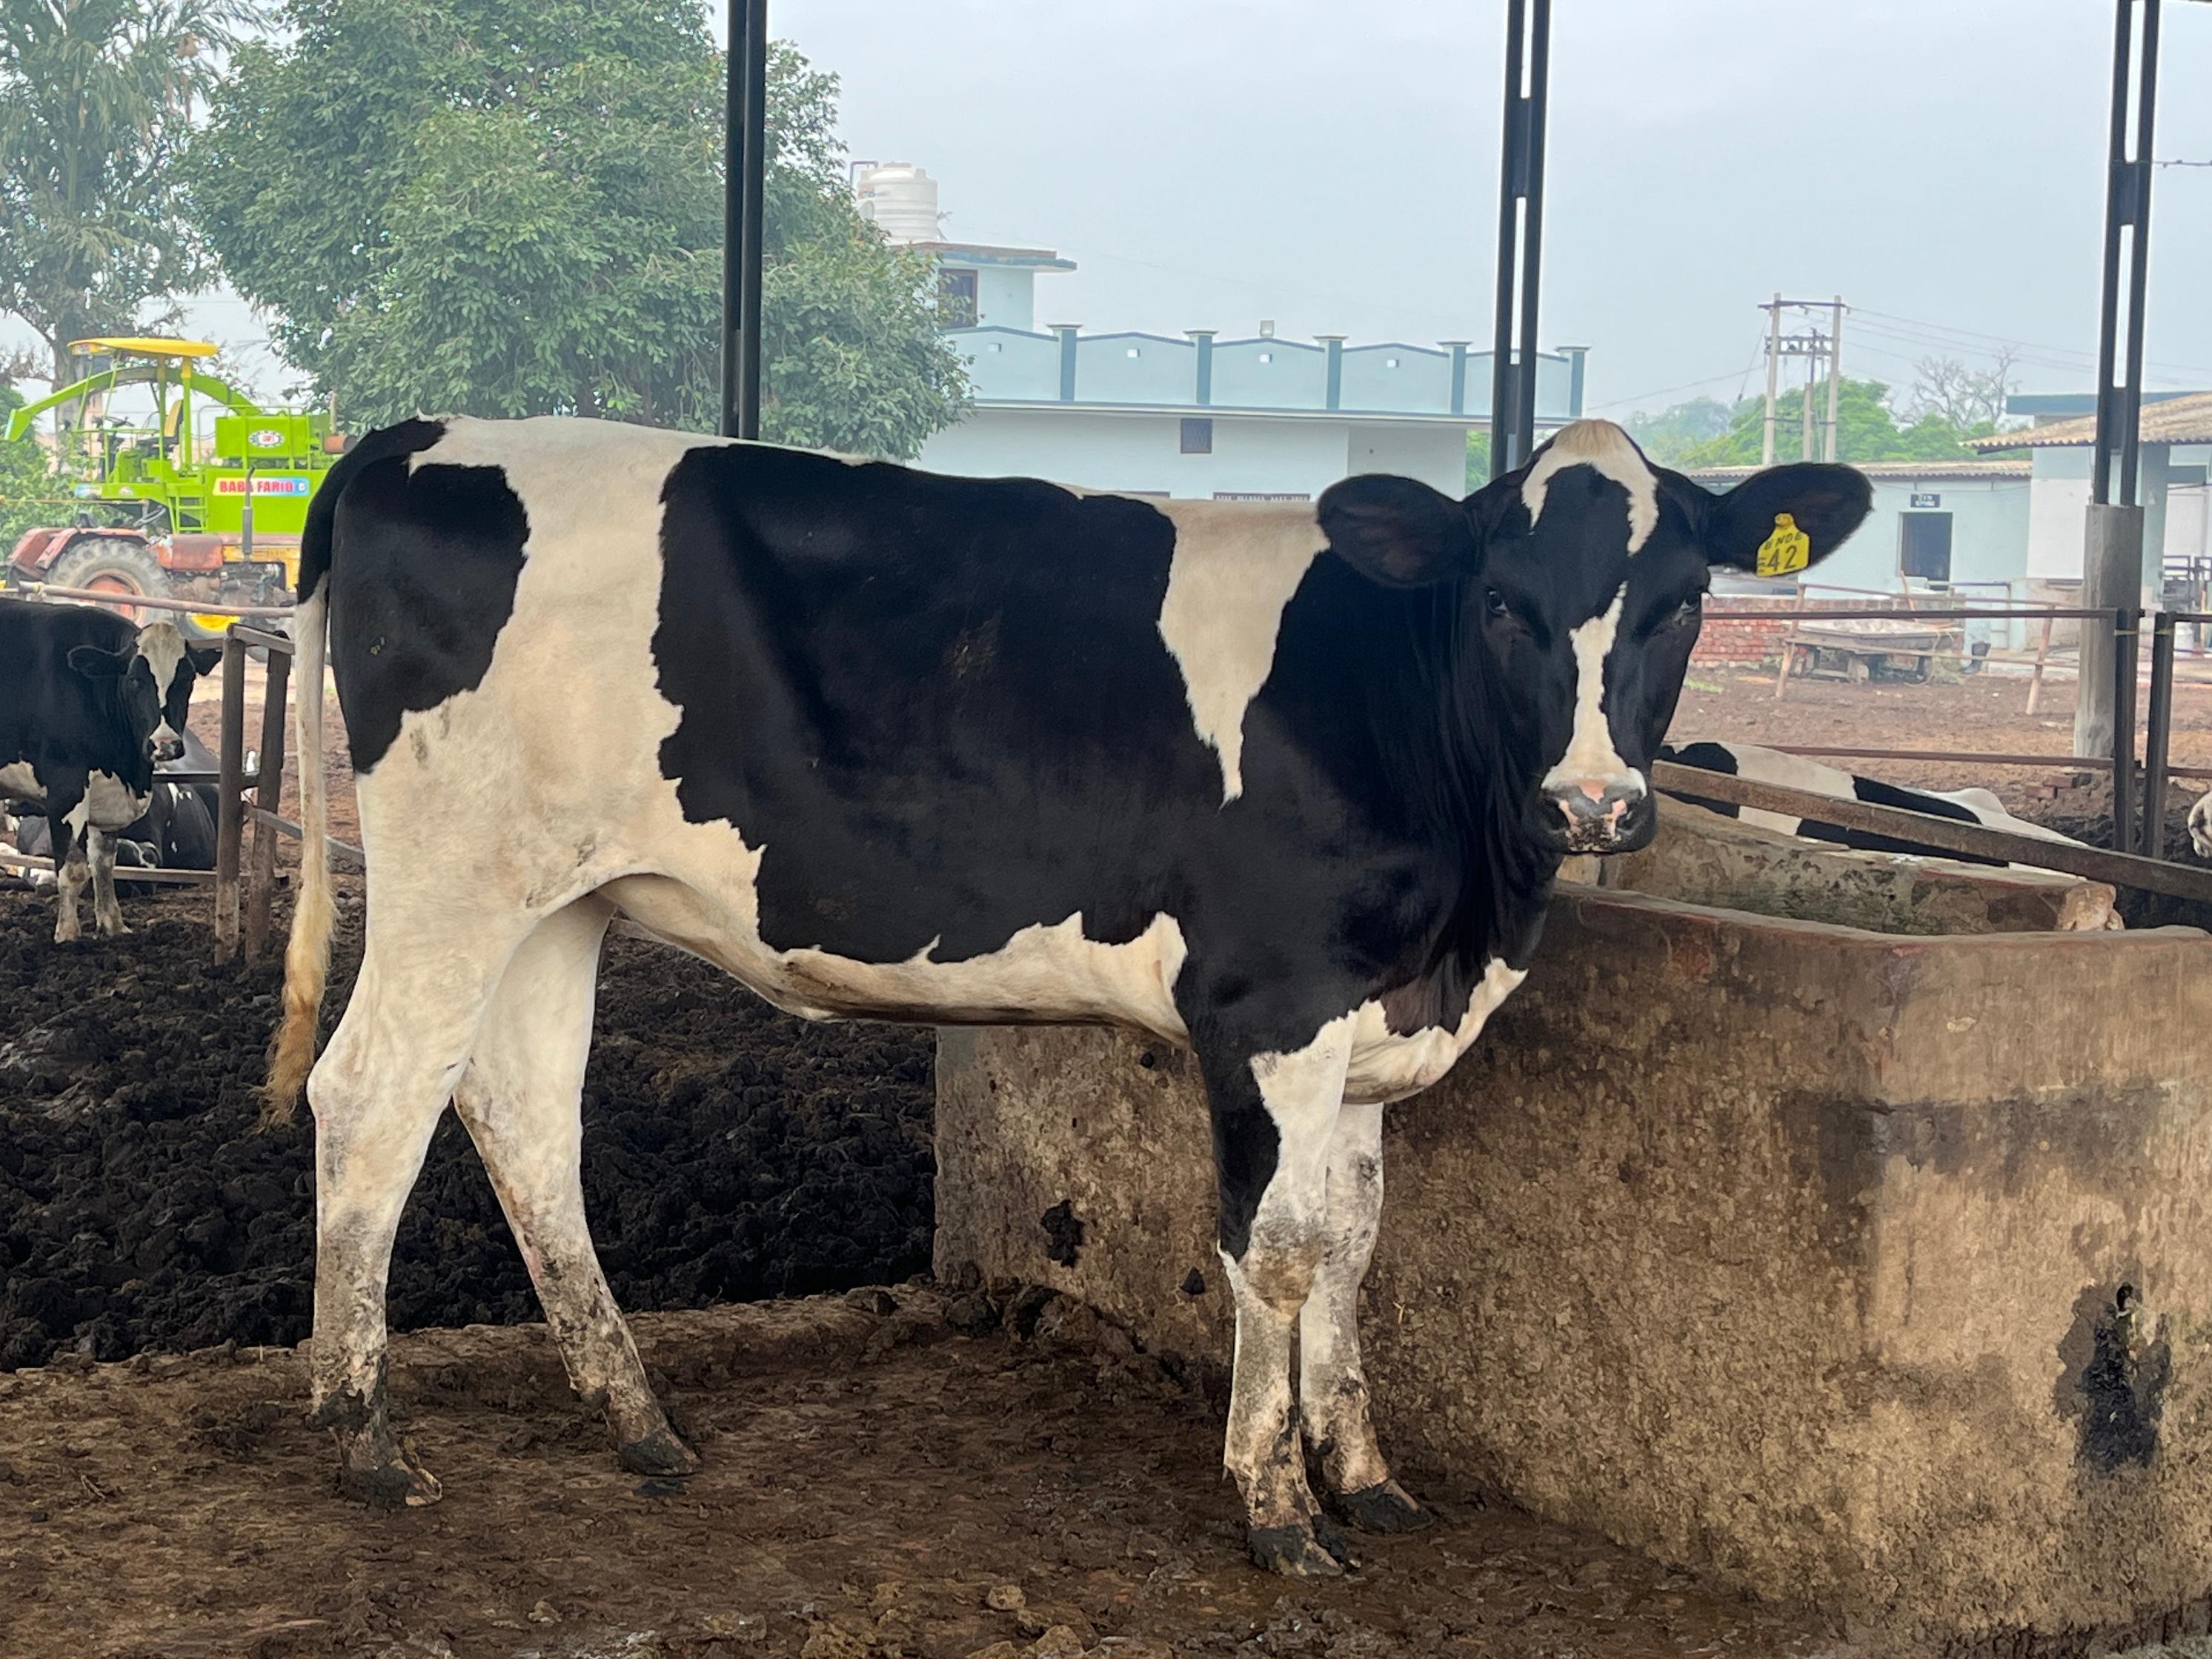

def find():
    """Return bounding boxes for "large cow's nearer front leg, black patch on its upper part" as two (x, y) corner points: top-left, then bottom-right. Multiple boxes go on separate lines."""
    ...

(1199, 1017), (1352, 1577)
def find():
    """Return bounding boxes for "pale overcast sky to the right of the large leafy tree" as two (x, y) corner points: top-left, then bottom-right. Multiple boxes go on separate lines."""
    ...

(760, 0), (2212, 413)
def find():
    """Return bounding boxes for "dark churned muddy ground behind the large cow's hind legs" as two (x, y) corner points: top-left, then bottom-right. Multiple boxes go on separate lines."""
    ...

(0, 889), (936, 1372)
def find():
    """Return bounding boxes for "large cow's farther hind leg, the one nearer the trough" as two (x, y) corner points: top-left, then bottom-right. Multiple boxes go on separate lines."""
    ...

(454, 898), (699, 1475)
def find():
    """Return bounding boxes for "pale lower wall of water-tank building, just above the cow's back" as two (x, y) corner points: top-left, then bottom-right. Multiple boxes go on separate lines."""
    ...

(920, 407), (1467, 500)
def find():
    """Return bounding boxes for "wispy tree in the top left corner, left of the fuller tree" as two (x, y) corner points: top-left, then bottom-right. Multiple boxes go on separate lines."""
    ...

(0, 0), (259, 382)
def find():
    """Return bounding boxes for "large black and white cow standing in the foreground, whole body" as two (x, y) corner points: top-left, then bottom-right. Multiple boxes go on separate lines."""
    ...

(270, 420), (1867, 1573)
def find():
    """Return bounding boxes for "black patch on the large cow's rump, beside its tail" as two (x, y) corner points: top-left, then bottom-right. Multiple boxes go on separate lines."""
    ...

(319, 451), (531, 774)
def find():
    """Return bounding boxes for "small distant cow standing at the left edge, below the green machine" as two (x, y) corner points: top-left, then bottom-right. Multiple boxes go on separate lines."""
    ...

(0, 599), (222, 945)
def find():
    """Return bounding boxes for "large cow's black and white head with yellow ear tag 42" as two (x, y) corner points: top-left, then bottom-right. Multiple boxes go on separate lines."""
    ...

(1318, 420), (1871, 851)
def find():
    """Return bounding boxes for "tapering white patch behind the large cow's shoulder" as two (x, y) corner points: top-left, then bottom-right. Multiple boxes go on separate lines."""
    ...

(1152, 502), (1327, 805)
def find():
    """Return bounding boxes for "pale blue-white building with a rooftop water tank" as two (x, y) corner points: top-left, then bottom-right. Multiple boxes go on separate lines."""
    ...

(854, 162), (1584, 500)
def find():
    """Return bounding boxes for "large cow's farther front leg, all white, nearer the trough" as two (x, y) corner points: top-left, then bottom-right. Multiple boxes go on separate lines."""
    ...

(1298, 1104), (1433, 1533)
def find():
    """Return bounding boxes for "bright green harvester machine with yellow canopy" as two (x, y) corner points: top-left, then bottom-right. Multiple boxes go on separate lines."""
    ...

(7, 339), (345, 635)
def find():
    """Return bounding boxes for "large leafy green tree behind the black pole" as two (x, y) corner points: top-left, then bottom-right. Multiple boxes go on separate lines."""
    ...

(190, 0), (966, 456)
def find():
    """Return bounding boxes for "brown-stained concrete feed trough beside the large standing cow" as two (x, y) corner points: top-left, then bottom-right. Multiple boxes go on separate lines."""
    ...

(936, 817), (2212, 1652)
